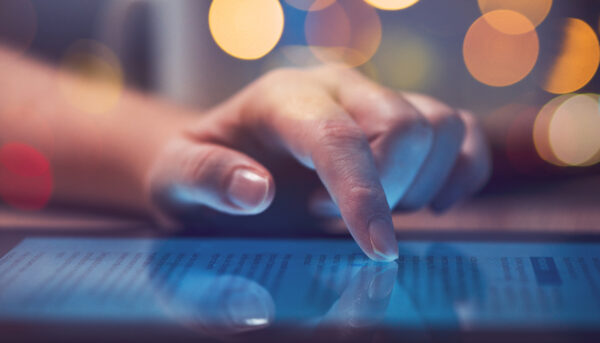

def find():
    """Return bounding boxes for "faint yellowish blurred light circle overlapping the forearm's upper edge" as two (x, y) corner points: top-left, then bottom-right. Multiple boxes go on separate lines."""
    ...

(58, 40), (124, 114)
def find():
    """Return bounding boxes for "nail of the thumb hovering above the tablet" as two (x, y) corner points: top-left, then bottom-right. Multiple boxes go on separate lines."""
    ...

(228, 168), (269, 210)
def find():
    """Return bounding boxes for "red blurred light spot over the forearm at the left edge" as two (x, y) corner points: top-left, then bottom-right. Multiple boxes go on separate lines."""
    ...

(0, 142), (53, 210)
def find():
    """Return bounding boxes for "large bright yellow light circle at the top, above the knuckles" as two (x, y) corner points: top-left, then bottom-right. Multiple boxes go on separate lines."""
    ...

(208, 0), (284, 60)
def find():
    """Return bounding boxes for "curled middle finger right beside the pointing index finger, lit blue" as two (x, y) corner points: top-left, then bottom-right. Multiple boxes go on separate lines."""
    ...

(338, 73), (434, 207)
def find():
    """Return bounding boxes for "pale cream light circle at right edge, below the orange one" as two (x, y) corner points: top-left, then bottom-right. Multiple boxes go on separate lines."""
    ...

(548, 94), (600, 166)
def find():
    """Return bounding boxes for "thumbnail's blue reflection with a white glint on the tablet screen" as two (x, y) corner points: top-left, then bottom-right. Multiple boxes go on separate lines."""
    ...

(227, 291), (270, 329)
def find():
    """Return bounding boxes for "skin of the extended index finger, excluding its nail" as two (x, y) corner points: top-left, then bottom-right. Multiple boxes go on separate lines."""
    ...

(237, 71), (394, 259)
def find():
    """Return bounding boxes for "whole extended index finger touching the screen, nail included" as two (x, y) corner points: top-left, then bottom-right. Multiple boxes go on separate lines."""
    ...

(248, 77), (398, 261)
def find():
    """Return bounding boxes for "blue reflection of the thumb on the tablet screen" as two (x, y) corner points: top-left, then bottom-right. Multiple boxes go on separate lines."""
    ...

(145, 242), (275, 338)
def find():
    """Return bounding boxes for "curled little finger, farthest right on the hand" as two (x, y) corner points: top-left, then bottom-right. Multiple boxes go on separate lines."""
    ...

(431, 111), (492, 213)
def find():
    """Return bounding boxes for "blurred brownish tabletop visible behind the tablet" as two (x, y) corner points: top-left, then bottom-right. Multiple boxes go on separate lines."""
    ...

(0, 176), (600, 235)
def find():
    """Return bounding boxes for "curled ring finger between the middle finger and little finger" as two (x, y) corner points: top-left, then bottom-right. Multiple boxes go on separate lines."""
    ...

(398, 94), (466, 210)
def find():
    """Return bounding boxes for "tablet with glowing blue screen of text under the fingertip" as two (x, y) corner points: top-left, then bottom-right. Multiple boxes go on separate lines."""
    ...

(0, 237), (600, 342)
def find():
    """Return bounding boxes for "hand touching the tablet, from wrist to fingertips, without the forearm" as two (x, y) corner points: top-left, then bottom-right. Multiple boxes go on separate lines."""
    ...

(147, 66), (490, 260)
